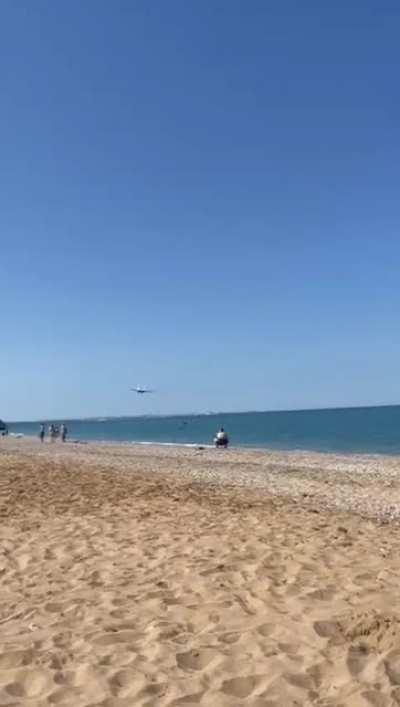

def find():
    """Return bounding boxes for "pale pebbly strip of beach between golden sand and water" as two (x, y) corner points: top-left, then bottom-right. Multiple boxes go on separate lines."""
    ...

(0, 437), (400, 523)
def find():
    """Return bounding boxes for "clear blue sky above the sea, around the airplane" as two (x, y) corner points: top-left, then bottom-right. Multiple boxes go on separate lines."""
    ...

(0, 0), (400, 420)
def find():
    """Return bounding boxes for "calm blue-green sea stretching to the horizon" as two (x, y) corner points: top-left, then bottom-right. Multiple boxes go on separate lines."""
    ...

(4, 405), (400, 455)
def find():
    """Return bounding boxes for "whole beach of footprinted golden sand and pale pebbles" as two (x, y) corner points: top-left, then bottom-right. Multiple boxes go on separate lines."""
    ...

(0, 438), (400, 707)
